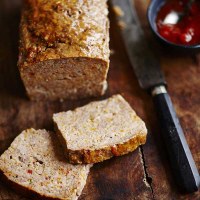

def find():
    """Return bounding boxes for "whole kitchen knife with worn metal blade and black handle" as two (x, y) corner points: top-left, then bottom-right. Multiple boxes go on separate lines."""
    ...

(111, 0), (200, 192)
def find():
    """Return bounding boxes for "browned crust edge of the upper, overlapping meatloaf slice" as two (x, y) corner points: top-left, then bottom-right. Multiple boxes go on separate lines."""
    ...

(54, 123), (147, 164)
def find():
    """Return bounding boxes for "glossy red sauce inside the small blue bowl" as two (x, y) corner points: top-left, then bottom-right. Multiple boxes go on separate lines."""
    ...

(156, 0), (200, 46)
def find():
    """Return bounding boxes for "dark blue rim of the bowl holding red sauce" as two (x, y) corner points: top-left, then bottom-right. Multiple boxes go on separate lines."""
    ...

(147, 0), (200, 49)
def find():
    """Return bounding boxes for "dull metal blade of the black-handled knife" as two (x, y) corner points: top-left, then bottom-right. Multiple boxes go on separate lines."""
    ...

(111, 0), (166, 89)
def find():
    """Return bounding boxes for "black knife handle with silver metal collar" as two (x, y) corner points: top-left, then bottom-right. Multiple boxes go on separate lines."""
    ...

(152, 85), (200, 193)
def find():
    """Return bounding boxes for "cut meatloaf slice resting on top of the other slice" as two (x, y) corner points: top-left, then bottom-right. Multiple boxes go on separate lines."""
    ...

(53, 95), (147, 164)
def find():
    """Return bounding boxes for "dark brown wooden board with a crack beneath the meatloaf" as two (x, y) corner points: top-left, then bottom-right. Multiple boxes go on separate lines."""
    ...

(0, 0), (200, 200)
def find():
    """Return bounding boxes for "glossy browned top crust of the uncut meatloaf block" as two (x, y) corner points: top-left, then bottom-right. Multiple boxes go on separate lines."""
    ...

(19, 0), (109, 67)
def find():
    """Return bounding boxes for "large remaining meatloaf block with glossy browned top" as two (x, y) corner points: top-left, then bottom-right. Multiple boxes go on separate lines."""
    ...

(18, 0), (110, 100)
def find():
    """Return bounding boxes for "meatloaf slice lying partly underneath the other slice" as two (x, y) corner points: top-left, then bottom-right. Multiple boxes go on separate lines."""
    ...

(0, 129), (91, 200)
